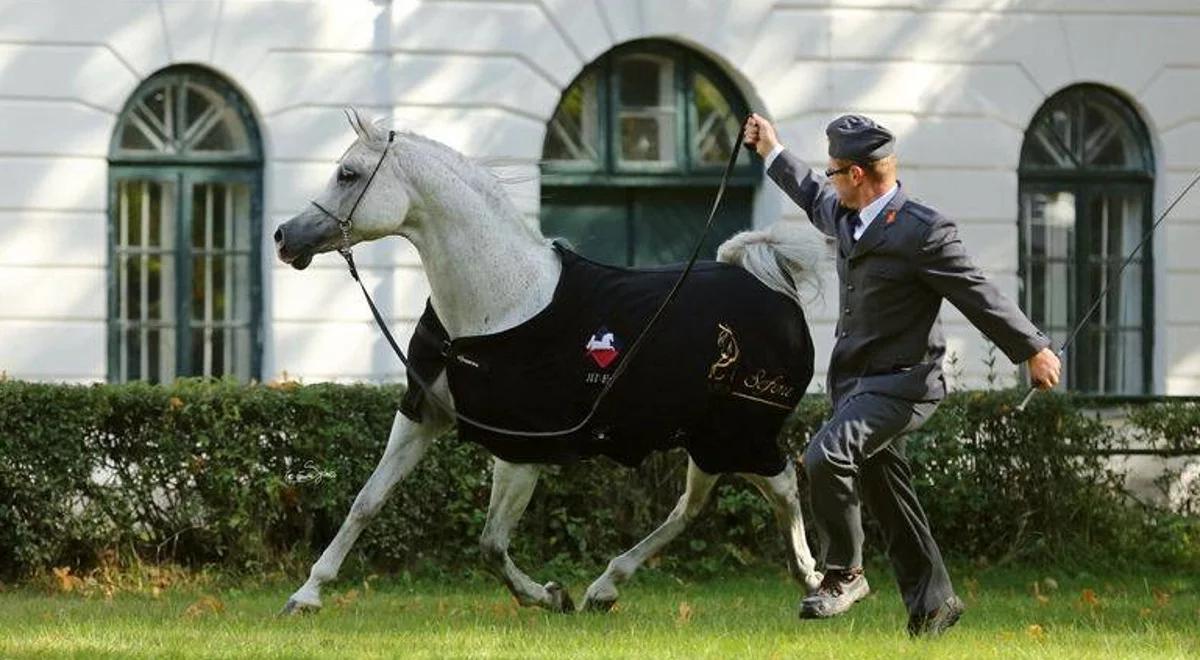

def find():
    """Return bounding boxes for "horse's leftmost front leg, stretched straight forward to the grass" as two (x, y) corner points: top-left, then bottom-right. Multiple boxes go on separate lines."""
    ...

(283, 413), (443, 613)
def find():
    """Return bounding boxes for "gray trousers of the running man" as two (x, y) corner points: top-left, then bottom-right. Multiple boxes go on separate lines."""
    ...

(804, 394), (954, 614)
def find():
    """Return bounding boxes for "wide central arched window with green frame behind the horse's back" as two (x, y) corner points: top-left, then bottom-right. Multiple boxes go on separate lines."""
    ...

(541, 41), (762, 265)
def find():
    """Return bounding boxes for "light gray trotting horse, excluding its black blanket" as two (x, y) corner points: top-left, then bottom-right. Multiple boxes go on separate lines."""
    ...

(275, 110), (821, 612)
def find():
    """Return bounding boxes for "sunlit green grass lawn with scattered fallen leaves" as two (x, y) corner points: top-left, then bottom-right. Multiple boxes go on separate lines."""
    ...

(0, 569), (1200, 659)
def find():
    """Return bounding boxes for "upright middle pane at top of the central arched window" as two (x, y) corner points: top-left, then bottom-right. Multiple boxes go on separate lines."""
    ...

(617, 55), (678, 164)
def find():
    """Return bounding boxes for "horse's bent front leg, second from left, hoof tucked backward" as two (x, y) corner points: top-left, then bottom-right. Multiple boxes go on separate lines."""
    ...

(479, 458), (575, 612)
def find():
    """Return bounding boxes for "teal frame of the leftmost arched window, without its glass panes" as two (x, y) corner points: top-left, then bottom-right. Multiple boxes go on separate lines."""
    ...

(107, 65), (264, 382)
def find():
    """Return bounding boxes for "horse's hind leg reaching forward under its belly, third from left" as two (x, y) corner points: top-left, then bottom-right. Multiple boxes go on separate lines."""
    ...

(583, 458), (718, 610)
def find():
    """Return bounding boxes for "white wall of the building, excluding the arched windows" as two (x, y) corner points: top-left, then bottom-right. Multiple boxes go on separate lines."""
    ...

(0, 0), (1200, 394)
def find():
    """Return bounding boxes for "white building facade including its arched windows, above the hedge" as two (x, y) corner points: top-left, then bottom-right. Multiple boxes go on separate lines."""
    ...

(0, 0), (1200, 395)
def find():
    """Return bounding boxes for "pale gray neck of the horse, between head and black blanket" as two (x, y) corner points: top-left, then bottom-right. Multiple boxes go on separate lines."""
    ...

(409, 149), (562, 337)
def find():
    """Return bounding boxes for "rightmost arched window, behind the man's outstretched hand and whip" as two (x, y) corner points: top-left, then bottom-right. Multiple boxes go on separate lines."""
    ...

(1020, 85), (1154, 394)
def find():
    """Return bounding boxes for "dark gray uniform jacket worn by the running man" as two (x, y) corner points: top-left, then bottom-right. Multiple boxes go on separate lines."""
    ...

(767, 151), (1050, 407)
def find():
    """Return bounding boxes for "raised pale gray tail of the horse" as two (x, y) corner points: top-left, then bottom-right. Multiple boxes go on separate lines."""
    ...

(716, 221), (824, 305)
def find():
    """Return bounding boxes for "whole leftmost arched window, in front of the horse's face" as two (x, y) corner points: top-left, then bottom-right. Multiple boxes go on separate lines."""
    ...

(108, 66), (262, 382)
